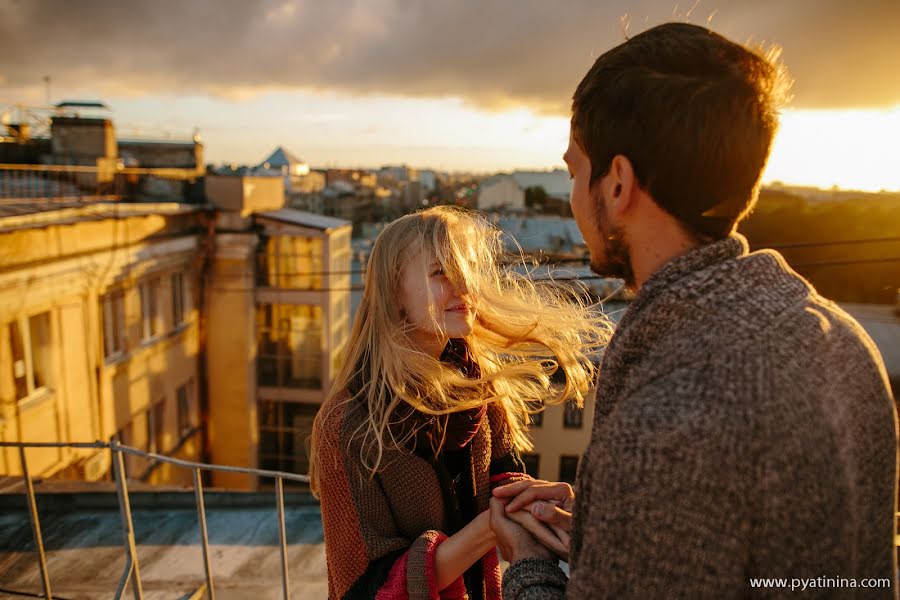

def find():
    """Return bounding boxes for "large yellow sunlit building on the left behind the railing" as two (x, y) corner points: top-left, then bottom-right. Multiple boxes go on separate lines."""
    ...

(0, 122), (351, 489)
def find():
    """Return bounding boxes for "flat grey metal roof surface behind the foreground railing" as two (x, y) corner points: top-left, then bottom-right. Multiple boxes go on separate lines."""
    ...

(0, 482), (328, 600)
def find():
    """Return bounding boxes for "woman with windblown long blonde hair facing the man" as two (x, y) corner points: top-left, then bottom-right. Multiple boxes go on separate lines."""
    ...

(310, 207), (608, 599)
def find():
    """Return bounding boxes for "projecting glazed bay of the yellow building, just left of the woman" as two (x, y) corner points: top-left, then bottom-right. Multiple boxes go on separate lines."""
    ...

(256, 219), (351, 486)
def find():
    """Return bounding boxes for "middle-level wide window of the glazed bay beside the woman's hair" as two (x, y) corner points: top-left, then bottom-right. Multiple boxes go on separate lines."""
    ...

(256, 304), (323, 389)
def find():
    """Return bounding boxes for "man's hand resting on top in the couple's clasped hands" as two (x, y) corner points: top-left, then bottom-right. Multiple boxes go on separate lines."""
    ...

(494, 480), (575, 560)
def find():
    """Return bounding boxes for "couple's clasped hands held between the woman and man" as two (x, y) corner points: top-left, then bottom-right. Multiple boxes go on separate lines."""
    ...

(490, 479), (575, 563)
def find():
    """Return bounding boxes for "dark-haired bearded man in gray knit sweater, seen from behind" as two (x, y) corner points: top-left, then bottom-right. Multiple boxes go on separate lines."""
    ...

(491, 23), (897, 600)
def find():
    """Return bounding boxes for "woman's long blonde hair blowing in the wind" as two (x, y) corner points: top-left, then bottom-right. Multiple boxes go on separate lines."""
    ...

(310, 206), (611, 493)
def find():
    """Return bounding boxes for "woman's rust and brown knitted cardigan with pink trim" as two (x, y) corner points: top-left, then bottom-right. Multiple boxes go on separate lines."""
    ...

(316, 392), (525, 600)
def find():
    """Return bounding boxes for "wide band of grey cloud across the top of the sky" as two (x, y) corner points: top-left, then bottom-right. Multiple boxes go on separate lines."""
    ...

(0, 0), (900, 114)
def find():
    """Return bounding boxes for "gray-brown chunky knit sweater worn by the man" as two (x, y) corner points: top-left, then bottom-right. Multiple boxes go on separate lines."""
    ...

(503, 235), (897, 600)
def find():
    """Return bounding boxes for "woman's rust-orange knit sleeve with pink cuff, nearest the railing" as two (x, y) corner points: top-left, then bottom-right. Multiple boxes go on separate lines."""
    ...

(316, 408), (465, 600)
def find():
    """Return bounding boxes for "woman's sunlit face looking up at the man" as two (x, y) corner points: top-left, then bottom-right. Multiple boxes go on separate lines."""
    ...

(400, 252), (475, 357)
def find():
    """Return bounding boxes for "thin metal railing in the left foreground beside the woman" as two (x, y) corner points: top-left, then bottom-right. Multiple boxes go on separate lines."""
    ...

(0, 441), (309, 600)
